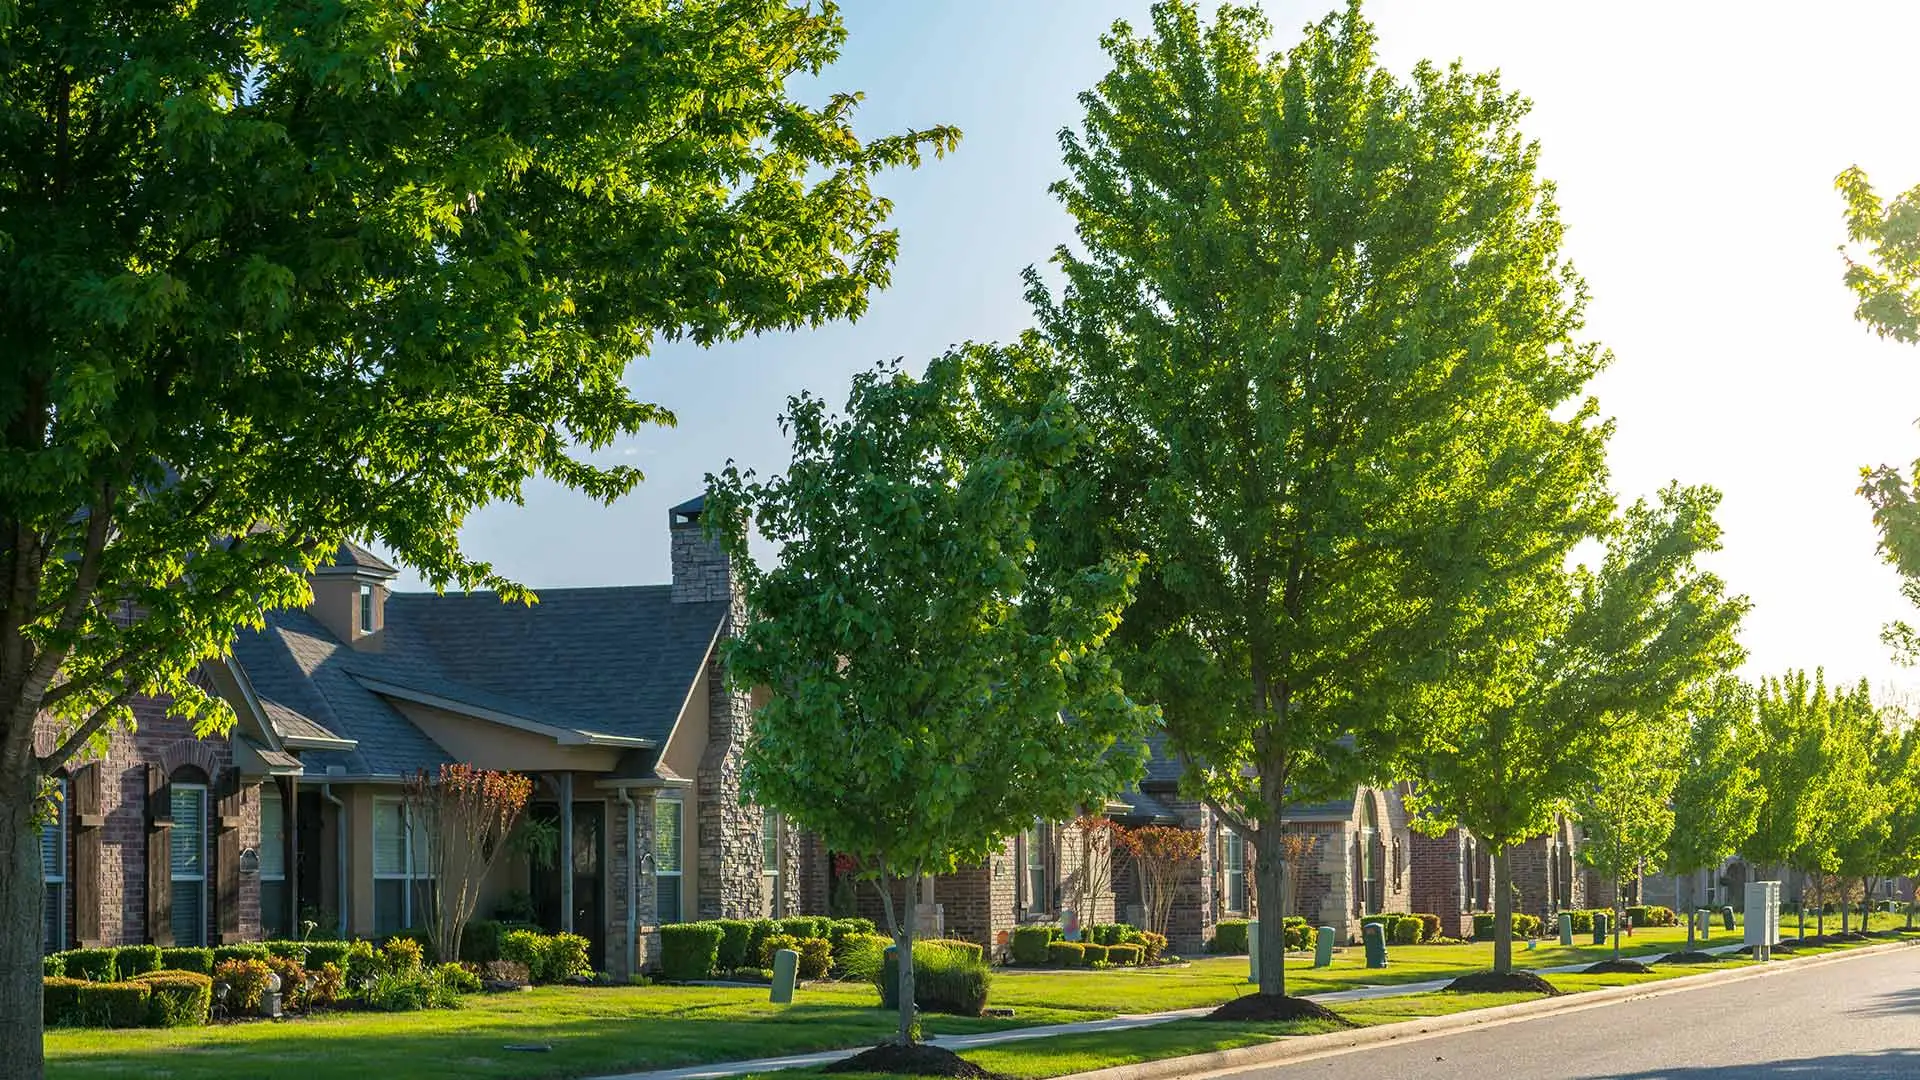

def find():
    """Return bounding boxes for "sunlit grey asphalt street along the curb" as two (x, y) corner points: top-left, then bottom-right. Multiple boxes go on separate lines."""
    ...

(1223, 949), (1920, 1080)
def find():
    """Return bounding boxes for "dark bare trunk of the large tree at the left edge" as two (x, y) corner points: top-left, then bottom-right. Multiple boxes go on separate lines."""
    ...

(0, 773), (44, 1080)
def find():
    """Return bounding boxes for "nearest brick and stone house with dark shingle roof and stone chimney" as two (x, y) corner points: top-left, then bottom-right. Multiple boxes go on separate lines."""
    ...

(42, 500), (794, 974)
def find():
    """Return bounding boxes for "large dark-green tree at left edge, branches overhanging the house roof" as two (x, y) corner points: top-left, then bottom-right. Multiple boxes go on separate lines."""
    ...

(0, 0), (956, 1078)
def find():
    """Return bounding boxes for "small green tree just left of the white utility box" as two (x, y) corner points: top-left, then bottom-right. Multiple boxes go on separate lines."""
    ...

(1665, 675), (1761, 951)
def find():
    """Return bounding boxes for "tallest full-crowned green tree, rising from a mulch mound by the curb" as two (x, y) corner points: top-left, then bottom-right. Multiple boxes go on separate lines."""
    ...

(1027, 0), (1607, 1013)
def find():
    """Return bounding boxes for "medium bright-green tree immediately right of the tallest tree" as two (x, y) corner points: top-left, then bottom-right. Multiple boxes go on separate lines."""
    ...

(1407, 484), (1747, 974)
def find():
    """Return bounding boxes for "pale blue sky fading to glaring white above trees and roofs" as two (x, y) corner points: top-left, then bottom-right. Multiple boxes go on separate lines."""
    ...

(401, 0), (1920, 692)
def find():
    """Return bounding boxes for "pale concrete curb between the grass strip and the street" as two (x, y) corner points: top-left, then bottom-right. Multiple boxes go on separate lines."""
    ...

(1054, 940), (1920, 1080)
